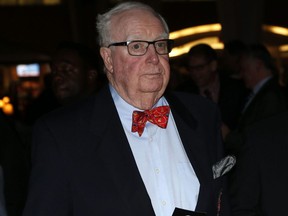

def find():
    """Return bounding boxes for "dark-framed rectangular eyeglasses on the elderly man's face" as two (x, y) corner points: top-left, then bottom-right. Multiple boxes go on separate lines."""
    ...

(108, 39), (174, 56)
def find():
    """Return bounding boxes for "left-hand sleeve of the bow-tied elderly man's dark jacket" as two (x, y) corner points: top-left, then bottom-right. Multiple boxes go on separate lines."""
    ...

(23, 119), (71, 216)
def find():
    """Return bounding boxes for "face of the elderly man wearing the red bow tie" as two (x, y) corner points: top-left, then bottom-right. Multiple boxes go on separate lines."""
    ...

(101, 10), (170, 105)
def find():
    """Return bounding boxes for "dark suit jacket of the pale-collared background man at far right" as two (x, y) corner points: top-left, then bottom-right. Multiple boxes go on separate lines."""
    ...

(225, 77), (287, 156)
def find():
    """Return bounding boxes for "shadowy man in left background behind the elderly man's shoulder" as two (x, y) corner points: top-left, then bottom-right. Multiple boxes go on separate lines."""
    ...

(27, 41), (104, 125)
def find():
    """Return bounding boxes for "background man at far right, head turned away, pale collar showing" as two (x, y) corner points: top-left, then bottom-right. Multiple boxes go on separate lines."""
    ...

(225, 44), (287, 155)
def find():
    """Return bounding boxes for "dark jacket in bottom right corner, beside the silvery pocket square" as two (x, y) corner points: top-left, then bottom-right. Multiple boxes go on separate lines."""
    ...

(231, 112), (288, 216)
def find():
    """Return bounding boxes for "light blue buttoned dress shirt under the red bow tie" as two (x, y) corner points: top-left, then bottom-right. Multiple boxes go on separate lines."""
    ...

(110, 86), (200, 216)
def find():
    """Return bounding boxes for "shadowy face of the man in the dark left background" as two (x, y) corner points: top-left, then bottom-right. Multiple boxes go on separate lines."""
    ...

(51, 50), (85, 104)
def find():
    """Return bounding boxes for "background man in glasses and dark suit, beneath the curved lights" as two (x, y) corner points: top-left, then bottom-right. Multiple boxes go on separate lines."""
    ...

(177, 44), (247, 137)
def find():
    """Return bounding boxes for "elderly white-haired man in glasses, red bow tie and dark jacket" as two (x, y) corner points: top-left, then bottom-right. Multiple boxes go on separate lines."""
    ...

(24, 2), (229, 216)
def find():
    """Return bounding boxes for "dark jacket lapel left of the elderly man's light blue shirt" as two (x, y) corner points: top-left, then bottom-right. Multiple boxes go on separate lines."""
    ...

(90, 88), (154, 216)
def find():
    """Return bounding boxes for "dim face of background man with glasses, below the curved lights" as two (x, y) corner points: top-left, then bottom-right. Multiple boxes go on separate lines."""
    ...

(188, 56), (216, 88)
